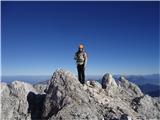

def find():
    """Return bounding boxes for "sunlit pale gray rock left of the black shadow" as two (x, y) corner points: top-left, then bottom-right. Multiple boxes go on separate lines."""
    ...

(1, 81), (36, 120)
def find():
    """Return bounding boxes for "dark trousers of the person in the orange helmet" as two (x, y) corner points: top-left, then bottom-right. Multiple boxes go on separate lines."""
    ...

(77, 64), (85, 84)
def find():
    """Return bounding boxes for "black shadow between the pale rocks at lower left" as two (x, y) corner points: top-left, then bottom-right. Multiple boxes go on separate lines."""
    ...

(27, 92), (46, 120)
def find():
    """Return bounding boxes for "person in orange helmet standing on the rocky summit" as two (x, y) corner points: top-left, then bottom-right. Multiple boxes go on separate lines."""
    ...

(74, 44), (88, 84)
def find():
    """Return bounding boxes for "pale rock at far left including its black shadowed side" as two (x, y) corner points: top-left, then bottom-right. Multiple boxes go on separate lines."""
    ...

(0, 81), (45, 120)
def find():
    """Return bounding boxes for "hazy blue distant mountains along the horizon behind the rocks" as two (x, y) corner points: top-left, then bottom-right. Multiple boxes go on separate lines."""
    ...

(1, 74), (160, 85)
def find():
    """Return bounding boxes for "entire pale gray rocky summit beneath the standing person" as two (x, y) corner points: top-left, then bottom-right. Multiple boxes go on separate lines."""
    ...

(0, 69), (160, 120)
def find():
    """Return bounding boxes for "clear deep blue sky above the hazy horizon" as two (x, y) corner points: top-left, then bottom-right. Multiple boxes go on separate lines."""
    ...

(1, 1), (159, 75)
